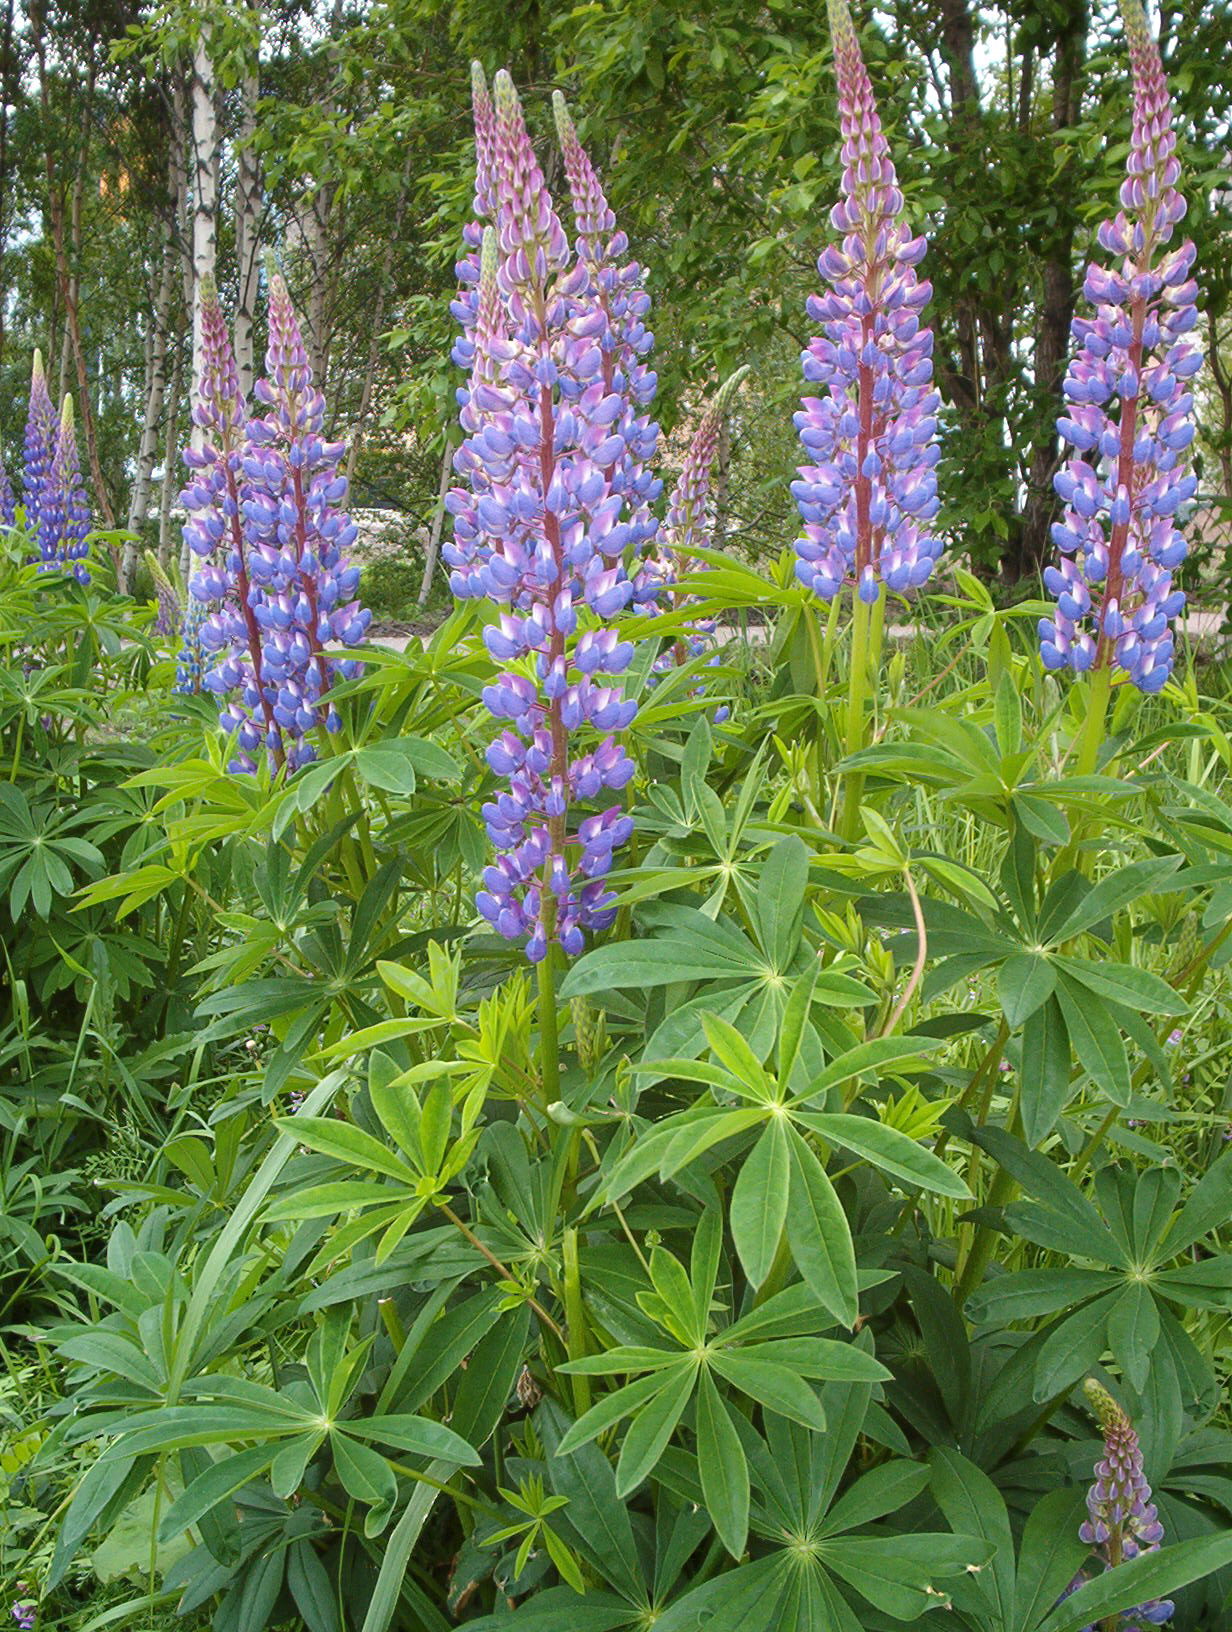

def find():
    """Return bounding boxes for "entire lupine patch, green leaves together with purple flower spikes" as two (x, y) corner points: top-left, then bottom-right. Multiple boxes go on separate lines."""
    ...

(0, 9), (1232, 1632)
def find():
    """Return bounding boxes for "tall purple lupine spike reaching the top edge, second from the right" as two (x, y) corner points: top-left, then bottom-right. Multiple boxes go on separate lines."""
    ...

(791, 0), (942, 604)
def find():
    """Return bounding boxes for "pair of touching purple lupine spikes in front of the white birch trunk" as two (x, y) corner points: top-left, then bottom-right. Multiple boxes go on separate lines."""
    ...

(183, 273), (370, 772)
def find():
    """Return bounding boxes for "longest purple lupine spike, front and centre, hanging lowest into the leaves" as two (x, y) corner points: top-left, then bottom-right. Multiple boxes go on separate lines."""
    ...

(444, 73), (645, 961)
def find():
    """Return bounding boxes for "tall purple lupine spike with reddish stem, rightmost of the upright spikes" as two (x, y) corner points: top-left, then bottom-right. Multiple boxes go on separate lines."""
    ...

(1039, 0), (1203, 692)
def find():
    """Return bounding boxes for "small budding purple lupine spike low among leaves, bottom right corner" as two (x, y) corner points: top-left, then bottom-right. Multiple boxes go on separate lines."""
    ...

(1066, 1379), (1175, 1632)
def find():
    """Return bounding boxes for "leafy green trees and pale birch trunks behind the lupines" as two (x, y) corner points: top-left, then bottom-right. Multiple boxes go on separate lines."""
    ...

(0, 0), (1232, 583)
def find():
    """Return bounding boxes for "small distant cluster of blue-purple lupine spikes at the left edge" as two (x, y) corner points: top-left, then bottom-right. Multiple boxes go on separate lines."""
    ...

(0, 351), (90, 584)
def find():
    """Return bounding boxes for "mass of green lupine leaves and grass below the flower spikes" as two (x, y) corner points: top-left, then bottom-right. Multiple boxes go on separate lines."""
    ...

(0, 525), (1232, 1632)
